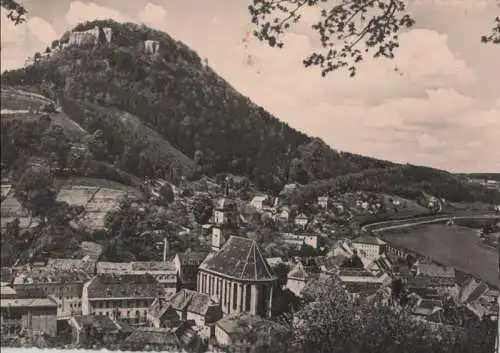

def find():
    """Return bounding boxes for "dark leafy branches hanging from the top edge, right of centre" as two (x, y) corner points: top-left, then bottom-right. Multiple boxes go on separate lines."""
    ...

(248, 0), (500, 77)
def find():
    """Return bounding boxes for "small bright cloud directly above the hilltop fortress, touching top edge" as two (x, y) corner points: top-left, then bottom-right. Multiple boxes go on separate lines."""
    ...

(65, 1), (131, 27)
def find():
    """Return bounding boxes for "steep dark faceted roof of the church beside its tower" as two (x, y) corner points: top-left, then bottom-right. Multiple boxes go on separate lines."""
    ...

(200, 236), (277, 281)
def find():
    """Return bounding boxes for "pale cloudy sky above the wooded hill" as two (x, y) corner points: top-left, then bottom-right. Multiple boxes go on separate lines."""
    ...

(1, 0), (500, 173)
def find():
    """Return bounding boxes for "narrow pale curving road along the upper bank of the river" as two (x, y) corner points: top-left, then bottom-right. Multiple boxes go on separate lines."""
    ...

(361, 213), (500, 233)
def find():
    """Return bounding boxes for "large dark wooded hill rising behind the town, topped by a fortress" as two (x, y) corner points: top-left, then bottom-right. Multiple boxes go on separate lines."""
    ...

(2, 20), (499, 201)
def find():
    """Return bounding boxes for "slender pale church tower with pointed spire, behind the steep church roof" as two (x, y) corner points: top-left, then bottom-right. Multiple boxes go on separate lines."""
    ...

(212, 179), (238, 251)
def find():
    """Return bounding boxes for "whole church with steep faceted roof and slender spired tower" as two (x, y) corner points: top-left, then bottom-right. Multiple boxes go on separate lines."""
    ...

(197, 189), (278, 317)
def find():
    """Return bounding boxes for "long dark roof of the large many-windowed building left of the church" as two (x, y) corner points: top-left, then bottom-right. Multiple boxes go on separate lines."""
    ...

(84, 273), (163, 299)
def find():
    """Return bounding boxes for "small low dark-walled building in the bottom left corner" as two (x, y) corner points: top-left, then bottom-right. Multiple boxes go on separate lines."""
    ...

(0, 290), (57, 338)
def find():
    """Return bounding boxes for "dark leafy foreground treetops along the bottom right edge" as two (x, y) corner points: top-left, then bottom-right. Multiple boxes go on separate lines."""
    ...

(293, 278), (495, 353)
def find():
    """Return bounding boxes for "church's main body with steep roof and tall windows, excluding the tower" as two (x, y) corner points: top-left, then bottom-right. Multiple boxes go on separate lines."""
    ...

(197, 236), (278, 317)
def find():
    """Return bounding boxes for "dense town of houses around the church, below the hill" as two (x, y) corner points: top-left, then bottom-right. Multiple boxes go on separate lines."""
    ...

(1, 177), (500, 351)
